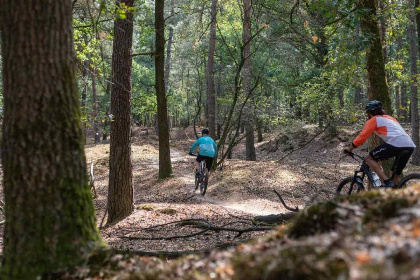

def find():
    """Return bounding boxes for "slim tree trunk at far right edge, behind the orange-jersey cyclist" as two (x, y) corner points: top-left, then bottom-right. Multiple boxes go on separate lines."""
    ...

(407, 0), (420, 165)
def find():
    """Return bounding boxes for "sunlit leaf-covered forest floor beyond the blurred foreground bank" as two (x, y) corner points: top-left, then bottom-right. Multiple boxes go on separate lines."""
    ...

(86, 123), (420, 253)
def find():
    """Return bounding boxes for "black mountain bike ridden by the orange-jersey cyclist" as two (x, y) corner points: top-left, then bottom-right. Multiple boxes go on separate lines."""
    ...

(336, 153), (420, 194)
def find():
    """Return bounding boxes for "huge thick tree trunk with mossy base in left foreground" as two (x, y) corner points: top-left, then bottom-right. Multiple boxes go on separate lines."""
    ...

(0, 0), (101, 280)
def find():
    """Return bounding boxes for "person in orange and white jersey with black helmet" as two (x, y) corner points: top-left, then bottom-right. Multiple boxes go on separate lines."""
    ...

(344, 100), (416, 188)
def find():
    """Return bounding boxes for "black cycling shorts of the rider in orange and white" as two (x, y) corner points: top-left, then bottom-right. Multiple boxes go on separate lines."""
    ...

(369, 143), (414, 175)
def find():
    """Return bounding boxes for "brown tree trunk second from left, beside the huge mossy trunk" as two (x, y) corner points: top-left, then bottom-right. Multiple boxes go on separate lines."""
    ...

(108, 0), (134, 223)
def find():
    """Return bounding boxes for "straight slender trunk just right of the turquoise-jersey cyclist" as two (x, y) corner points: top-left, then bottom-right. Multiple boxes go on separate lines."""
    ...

(242, 0), (256, 160)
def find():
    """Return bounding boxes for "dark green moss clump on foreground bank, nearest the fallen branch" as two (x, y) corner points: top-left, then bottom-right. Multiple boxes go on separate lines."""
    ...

(287, 202), (338, 238)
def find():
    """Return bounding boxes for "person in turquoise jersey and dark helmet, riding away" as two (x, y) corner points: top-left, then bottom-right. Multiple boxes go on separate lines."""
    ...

(189, 128), (217, 176)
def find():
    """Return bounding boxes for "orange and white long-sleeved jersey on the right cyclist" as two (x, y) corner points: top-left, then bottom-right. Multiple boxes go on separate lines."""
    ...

(353, 115), (416, 148)
